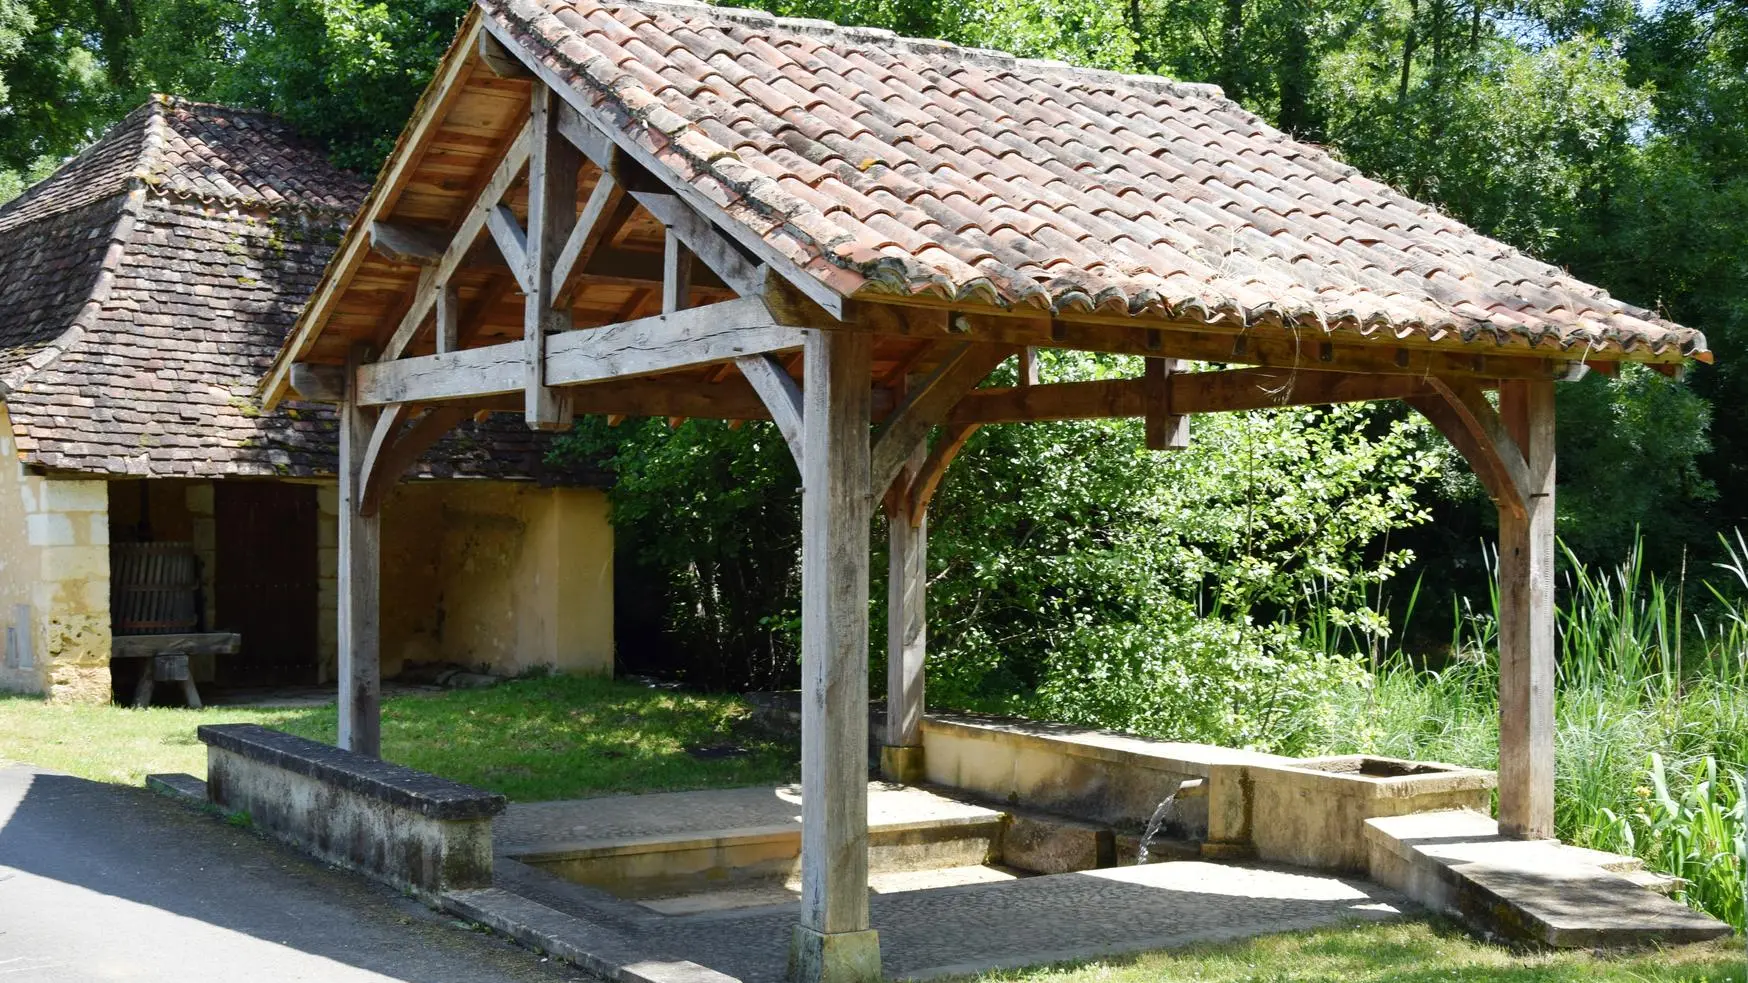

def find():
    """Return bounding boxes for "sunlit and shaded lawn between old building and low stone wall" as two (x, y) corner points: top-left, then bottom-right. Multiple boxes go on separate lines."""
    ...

(0, 675), (799, 801)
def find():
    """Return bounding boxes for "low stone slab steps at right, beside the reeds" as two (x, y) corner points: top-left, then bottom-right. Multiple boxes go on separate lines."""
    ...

(1365, 810), (1731, 948)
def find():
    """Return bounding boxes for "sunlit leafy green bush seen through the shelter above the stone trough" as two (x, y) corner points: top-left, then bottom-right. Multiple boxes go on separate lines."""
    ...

(915, 355), (1440, 749)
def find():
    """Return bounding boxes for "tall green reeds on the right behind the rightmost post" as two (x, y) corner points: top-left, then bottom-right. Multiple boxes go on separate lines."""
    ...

(1318, 533), (1748, 931)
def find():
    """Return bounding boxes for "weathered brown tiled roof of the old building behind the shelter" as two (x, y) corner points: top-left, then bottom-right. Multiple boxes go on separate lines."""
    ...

(0, 96), (589, 481)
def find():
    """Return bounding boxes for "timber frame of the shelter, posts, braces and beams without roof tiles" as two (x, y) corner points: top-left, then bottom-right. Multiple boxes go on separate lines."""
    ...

(288, 19), (1582, 966)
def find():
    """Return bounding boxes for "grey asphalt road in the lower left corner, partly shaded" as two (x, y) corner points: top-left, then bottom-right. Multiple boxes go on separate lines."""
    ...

(0, 764), (587, 983)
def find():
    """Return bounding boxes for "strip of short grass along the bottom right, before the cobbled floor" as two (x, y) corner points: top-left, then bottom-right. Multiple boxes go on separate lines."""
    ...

(977, 922), (1748, 983)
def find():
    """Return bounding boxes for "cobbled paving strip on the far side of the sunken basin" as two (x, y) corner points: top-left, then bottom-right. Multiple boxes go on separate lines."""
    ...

(491, 782), (1000, 854)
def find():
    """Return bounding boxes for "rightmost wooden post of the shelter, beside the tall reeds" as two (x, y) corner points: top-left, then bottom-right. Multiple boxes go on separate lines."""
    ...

(1500, 381), (1554, 829)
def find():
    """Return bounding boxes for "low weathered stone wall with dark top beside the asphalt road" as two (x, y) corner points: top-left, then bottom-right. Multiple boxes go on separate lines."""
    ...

(199, 724), (503, 901)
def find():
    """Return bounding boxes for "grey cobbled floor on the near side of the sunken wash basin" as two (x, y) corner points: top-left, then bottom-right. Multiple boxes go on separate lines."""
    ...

(485, 846), (1405, 983)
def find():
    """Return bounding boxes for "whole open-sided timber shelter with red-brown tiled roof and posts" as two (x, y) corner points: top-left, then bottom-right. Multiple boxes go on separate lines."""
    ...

(266, 0), (1706, 981)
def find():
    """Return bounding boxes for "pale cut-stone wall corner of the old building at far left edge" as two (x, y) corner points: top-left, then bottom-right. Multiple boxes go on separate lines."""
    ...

(0, 408), (110, 703)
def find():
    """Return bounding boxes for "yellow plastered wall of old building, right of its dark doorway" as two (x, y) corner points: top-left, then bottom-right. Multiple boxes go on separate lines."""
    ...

(332, 481), (614, 677)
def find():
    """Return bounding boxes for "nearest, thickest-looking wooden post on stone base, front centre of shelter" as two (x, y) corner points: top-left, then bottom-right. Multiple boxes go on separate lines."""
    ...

(788, 331), (881, 983)
